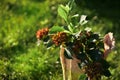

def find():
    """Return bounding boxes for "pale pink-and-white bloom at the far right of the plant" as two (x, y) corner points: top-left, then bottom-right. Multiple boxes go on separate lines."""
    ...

(103, 32), (115, 58)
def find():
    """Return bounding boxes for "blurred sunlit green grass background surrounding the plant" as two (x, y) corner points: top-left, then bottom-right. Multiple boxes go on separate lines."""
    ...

(0, 0), (120, 80)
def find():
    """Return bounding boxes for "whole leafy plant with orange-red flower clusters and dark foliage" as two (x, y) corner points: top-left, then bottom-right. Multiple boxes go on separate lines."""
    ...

(36, 0), (115, 80)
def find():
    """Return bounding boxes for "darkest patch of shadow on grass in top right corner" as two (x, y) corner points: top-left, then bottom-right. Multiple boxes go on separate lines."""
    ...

(75, 0), (120, 20)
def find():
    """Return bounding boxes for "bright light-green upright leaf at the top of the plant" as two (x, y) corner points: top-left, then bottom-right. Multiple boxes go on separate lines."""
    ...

(58, 5), (68, 21)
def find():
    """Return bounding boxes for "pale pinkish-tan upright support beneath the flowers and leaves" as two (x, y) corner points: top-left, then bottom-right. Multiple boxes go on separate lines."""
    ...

(60, 47), (82, 80)
